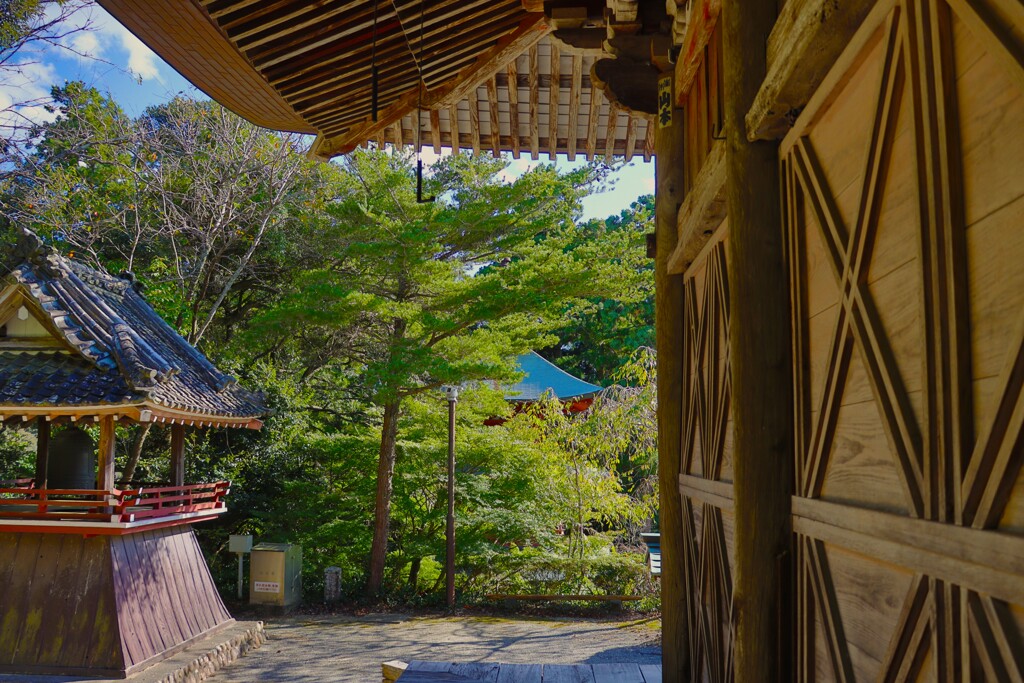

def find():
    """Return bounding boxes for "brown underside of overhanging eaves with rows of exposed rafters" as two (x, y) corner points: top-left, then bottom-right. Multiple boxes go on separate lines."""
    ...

(99, 0), (653, 159)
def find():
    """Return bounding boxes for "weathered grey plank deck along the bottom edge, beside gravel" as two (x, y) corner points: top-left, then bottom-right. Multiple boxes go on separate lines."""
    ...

(398, 660), (662, 683)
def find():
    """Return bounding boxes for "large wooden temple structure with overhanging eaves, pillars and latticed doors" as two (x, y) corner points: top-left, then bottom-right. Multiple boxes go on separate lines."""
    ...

(58, 0), (1024, 683)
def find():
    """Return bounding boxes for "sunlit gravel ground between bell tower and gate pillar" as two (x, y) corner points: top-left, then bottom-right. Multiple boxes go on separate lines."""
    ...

(207, 614), (662, 683)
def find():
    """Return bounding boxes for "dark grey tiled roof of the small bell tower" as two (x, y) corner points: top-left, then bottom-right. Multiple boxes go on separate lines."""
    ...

(0, 234), (266, 419)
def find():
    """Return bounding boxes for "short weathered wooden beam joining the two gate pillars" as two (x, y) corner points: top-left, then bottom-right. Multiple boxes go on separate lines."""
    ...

(671, 140), (726, 272)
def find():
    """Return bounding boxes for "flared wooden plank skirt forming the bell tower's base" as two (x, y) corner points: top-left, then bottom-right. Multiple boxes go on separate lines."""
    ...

(0, 525), (233, 677)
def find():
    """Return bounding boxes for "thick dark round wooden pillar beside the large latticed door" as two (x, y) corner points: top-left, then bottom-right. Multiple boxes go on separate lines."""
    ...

(722, 0), (793, 683)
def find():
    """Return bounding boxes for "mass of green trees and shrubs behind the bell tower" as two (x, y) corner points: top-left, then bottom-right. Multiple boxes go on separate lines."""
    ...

(0, 83), (656, 594)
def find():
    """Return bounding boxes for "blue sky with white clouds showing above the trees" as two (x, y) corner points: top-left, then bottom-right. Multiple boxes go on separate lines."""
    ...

(0, 6), (654, 223)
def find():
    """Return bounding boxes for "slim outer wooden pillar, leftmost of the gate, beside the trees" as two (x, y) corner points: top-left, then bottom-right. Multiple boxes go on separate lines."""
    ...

(649, 100), (690, 683)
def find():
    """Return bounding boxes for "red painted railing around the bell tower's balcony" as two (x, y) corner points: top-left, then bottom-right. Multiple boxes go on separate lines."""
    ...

(0, 479), (230, 523)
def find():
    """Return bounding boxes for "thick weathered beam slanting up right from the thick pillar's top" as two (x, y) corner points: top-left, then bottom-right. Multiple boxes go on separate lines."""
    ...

(745, 0), (873, 140)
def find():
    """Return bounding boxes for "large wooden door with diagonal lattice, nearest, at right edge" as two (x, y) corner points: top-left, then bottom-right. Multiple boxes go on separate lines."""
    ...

(780, 0), (1024, 683)
